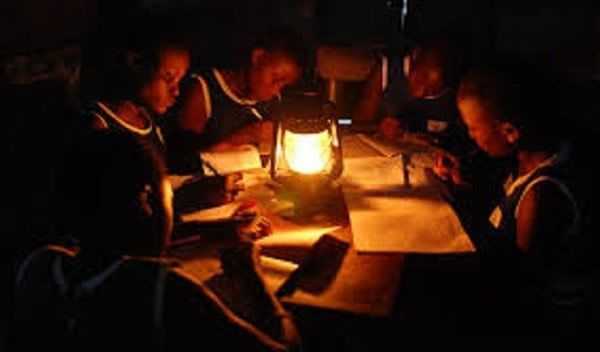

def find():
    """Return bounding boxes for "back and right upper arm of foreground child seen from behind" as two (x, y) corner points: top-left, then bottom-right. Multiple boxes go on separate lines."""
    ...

(13, 245), (292, 351)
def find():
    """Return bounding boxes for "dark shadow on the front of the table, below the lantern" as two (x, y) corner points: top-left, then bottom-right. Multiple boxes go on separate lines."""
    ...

(276, 234), (350, 297)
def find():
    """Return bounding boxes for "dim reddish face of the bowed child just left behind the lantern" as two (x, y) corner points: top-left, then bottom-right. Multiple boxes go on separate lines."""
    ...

(248, 49), (301, 101)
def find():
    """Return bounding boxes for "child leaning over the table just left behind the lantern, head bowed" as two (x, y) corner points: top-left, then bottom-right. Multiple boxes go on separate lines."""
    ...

(165, 25), (306, 171)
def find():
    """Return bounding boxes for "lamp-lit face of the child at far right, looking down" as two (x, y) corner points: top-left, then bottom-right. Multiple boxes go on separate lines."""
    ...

(458, 97), (513, 157)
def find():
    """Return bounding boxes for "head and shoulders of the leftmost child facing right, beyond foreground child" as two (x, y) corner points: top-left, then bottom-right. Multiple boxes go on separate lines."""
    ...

(81, 13), (190, 157)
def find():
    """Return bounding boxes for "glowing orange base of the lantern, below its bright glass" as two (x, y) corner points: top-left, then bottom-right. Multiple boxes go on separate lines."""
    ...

(270, 175), (338, 218)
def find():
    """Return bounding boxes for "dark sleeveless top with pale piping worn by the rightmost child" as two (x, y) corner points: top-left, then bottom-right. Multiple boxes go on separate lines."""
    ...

(489, 145), (585, 308)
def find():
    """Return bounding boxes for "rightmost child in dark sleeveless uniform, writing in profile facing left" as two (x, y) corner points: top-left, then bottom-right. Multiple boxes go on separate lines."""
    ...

(435, 59), (590, 334)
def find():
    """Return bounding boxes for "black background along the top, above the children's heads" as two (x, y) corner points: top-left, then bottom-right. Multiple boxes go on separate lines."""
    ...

(0, 0), (600, 81)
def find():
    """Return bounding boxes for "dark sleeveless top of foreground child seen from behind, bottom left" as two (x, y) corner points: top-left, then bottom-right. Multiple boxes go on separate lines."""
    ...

(15, 245), (172, 350)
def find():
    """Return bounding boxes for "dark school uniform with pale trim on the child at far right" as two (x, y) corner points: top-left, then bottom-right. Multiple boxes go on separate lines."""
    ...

(487, 143), (589, 334)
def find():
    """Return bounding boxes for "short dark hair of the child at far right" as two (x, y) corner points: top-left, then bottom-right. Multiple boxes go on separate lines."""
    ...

(457, 55), (564, 149)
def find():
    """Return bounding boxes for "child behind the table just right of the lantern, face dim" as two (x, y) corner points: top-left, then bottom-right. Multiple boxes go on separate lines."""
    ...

(355, 38), (465, 154)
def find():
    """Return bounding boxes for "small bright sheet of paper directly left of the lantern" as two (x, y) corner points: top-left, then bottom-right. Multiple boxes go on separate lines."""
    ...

(200, 144), (262, 175)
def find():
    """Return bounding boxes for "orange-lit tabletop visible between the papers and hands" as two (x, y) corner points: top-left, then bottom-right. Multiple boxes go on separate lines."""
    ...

(170, 132), (474, 317)
